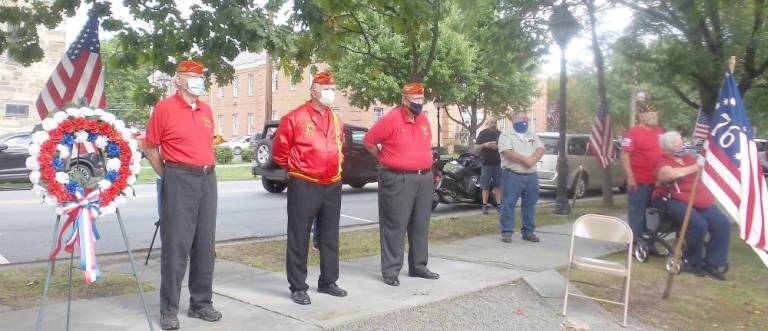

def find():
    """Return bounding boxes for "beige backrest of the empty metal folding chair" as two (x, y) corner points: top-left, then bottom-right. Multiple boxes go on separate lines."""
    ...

(573, 214), (632, 244)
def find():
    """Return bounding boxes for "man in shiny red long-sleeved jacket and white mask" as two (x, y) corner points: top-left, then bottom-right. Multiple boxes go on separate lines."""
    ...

(272, 72), (347, 305)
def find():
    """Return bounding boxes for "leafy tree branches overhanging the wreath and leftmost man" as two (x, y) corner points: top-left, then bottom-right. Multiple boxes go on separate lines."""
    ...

(0, 0), (298, 82)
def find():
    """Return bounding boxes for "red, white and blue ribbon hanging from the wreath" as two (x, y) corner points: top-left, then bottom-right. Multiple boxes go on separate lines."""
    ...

(50, 190), (101, 284)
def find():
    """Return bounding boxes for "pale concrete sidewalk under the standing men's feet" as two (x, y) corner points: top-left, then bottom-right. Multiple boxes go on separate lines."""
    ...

(0, 224), (648, 330)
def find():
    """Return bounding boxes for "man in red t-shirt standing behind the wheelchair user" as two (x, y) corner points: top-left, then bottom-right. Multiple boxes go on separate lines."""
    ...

(621, 105), (664, 254)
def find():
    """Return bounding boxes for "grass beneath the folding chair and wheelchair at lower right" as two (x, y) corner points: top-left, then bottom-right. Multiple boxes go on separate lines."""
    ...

(561, 227), (768, 330)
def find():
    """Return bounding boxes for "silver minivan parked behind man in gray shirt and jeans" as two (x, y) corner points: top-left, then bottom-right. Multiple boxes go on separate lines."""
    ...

(537, 132), (627, 198)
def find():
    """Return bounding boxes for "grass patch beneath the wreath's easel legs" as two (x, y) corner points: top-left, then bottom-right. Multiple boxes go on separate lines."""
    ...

(0, 261), (154, 312)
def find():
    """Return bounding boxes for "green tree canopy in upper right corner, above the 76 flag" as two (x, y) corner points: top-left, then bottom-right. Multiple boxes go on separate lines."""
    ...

(614, 0), (768, 113)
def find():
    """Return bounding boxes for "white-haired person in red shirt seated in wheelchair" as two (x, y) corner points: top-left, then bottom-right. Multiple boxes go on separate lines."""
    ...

(651, 131), (731, 280)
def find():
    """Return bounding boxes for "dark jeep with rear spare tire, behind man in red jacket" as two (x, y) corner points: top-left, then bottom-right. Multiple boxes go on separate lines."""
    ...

(251, 121), (379, 193)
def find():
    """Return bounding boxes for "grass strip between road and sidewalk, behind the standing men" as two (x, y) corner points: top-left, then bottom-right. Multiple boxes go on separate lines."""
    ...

(216, 198), (626, 271)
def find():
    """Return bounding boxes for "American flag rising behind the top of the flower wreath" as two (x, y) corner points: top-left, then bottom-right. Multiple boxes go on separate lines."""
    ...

(37, 12), (107, 119)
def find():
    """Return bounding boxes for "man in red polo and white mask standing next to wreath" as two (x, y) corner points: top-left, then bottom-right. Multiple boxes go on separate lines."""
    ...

(145, 60), (221, 330)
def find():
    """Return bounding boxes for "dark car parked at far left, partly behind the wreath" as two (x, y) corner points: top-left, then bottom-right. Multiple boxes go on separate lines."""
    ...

(0, 132), (104, 183)
